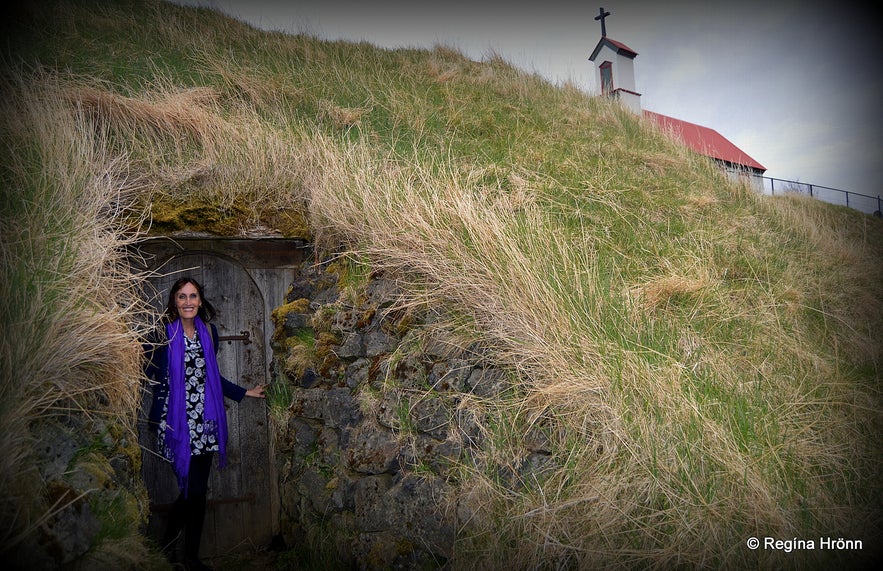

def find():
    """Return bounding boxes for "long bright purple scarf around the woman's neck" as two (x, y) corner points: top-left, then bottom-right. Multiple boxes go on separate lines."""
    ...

(164, 317), (227, 492)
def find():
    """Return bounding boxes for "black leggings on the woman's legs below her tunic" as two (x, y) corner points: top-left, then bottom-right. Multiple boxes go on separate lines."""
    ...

(163, 453), (214, 559)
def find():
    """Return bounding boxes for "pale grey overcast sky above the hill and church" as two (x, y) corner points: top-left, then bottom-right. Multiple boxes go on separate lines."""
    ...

(174, 0), (883, 200)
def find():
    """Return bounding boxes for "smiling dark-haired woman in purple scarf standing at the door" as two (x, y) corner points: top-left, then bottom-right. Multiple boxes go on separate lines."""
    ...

(145, 277), (266, 569)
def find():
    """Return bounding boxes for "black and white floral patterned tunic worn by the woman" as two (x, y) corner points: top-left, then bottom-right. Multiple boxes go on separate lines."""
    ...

(158, 333), (218, 456)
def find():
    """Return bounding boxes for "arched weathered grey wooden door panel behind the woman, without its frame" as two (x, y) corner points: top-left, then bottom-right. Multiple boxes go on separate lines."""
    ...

(139, 251), (273, 557)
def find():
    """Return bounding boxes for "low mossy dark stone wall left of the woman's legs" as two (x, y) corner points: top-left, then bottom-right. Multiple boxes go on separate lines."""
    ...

(0, 411), (149, 570)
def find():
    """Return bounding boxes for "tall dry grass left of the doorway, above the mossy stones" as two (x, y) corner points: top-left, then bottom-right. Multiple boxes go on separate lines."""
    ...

(0, 69), (152, 548)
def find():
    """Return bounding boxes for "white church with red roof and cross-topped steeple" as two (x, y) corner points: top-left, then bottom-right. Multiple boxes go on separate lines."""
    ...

(589, 8), (766, 190)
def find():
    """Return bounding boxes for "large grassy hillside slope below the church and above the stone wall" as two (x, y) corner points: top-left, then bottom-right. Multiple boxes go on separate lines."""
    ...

(3, 1), (883, 567)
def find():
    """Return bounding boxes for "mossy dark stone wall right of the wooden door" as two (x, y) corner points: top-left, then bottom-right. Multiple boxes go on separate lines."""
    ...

(274, 264), (532, 569)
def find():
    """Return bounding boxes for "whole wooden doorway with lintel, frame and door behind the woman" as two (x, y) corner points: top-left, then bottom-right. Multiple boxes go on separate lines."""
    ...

(138, 238), (307, 558)
